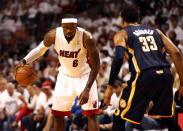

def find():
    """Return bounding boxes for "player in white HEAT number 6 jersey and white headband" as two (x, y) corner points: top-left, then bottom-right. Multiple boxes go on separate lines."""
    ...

(17, 14), (100, 131)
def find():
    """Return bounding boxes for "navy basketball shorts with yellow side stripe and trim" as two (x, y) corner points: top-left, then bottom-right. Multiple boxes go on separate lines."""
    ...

(115, 67), (174, 124)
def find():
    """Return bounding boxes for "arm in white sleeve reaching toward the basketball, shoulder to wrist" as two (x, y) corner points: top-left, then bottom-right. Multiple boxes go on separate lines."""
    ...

(23, 29), (56, 64)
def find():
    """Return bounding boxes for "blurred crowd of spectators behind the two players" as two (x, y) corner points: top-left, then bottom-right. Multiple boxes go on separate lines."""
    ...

(0, 0), (183, 131)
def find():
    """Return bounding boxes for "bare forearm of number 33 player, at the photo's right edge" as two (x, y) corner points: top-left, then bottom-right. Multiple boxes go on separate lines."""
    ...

(172, 51), (183, 85)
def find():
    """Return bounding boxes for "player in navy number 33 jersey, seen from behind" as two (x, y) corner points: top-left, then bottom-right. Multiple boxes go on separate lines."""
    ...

(104, 7), (183, 131)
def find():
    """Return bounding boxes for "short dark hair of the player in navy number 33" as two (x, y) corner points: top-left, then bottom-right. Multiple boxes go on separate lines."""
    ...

(121, 6), (139, 23)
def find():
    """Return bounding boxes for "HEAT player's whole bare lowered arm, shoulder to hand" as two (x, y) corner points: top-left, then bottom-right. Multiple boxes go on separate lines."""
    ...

(79, 31), (100, 105)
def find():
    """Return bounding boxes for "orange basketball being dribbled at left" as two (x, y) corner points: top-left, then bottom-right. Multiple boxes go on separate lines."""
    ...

(15, 65), (36, 86)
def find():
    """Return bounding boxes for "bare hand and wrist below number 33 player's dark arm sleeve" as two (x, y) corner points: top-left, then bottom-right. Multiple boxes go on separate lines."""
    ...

(104, 85), (113, 106)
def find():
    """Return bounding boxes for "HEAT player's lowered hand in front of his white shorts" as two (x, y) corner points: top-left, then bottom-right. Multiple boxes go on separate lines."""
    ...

(79, 88), (90, 105)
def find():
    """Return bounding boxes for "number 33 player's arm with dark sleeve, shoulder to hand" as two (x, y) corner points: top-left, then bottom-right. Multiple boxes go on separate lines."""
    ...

(104, 30), (127, 106)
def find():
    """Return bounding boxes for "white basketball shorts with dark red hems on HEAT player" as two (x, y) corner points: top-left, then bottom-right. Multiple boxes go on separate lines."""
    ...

(52, 73), (99, 116)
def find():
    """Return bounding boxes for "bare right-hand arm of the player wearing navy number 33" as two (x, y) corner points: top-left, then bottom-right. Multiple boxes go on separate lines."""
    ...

(158, 30), (183, 99)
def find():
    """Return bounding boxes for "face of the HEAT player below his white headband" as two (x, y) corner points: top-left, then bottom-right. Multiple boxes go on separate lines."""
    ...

(62, 23), (77, 38)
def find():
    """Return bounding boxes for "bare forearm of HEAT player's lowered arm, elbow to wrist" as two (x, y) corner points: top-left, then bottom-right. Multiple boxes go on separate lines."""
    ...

(86, 52), (100, 89)
